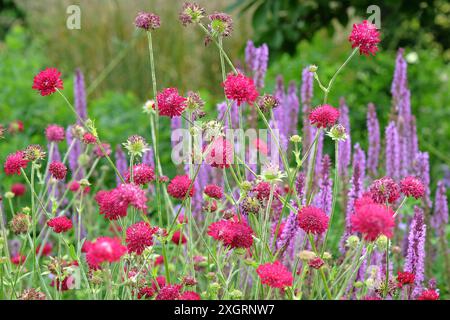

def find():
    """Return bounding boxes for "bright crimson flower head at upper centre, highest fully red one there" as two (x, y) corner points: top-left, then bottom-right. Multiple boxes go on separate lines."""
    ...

(223, 73), (258, 106)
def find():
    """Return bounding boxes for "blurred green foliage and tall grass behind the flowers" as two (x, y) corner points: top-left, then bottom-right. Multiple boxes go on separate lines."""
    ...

(0, 0), (450, 188)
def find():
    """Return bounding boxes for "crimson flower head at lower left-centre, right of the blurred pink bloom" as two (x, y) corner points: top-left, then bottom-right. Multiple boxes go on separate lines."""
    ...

(125, 221), (158, 255)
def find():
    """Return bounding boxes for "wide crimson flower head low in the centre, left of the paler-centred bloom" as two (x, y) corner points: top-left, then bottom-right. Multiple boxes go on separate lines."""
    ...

(208, 217), (253, 248)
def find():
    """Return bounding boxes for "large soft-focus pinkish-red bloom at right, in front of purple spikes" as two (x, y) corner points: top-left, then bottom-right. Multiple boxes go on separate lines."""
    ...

(350, 204), (395, 241)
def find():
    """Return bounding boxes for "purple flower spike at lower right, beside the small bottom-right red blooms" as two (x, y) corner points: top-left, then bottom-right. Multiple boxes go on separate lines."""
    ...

(405, 206), (426, 297)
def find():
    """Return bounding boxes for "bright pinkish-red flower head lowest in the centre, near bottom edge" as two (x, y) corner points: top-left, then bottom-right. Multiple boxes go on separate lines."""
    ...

(256, 260), (294, 289)
